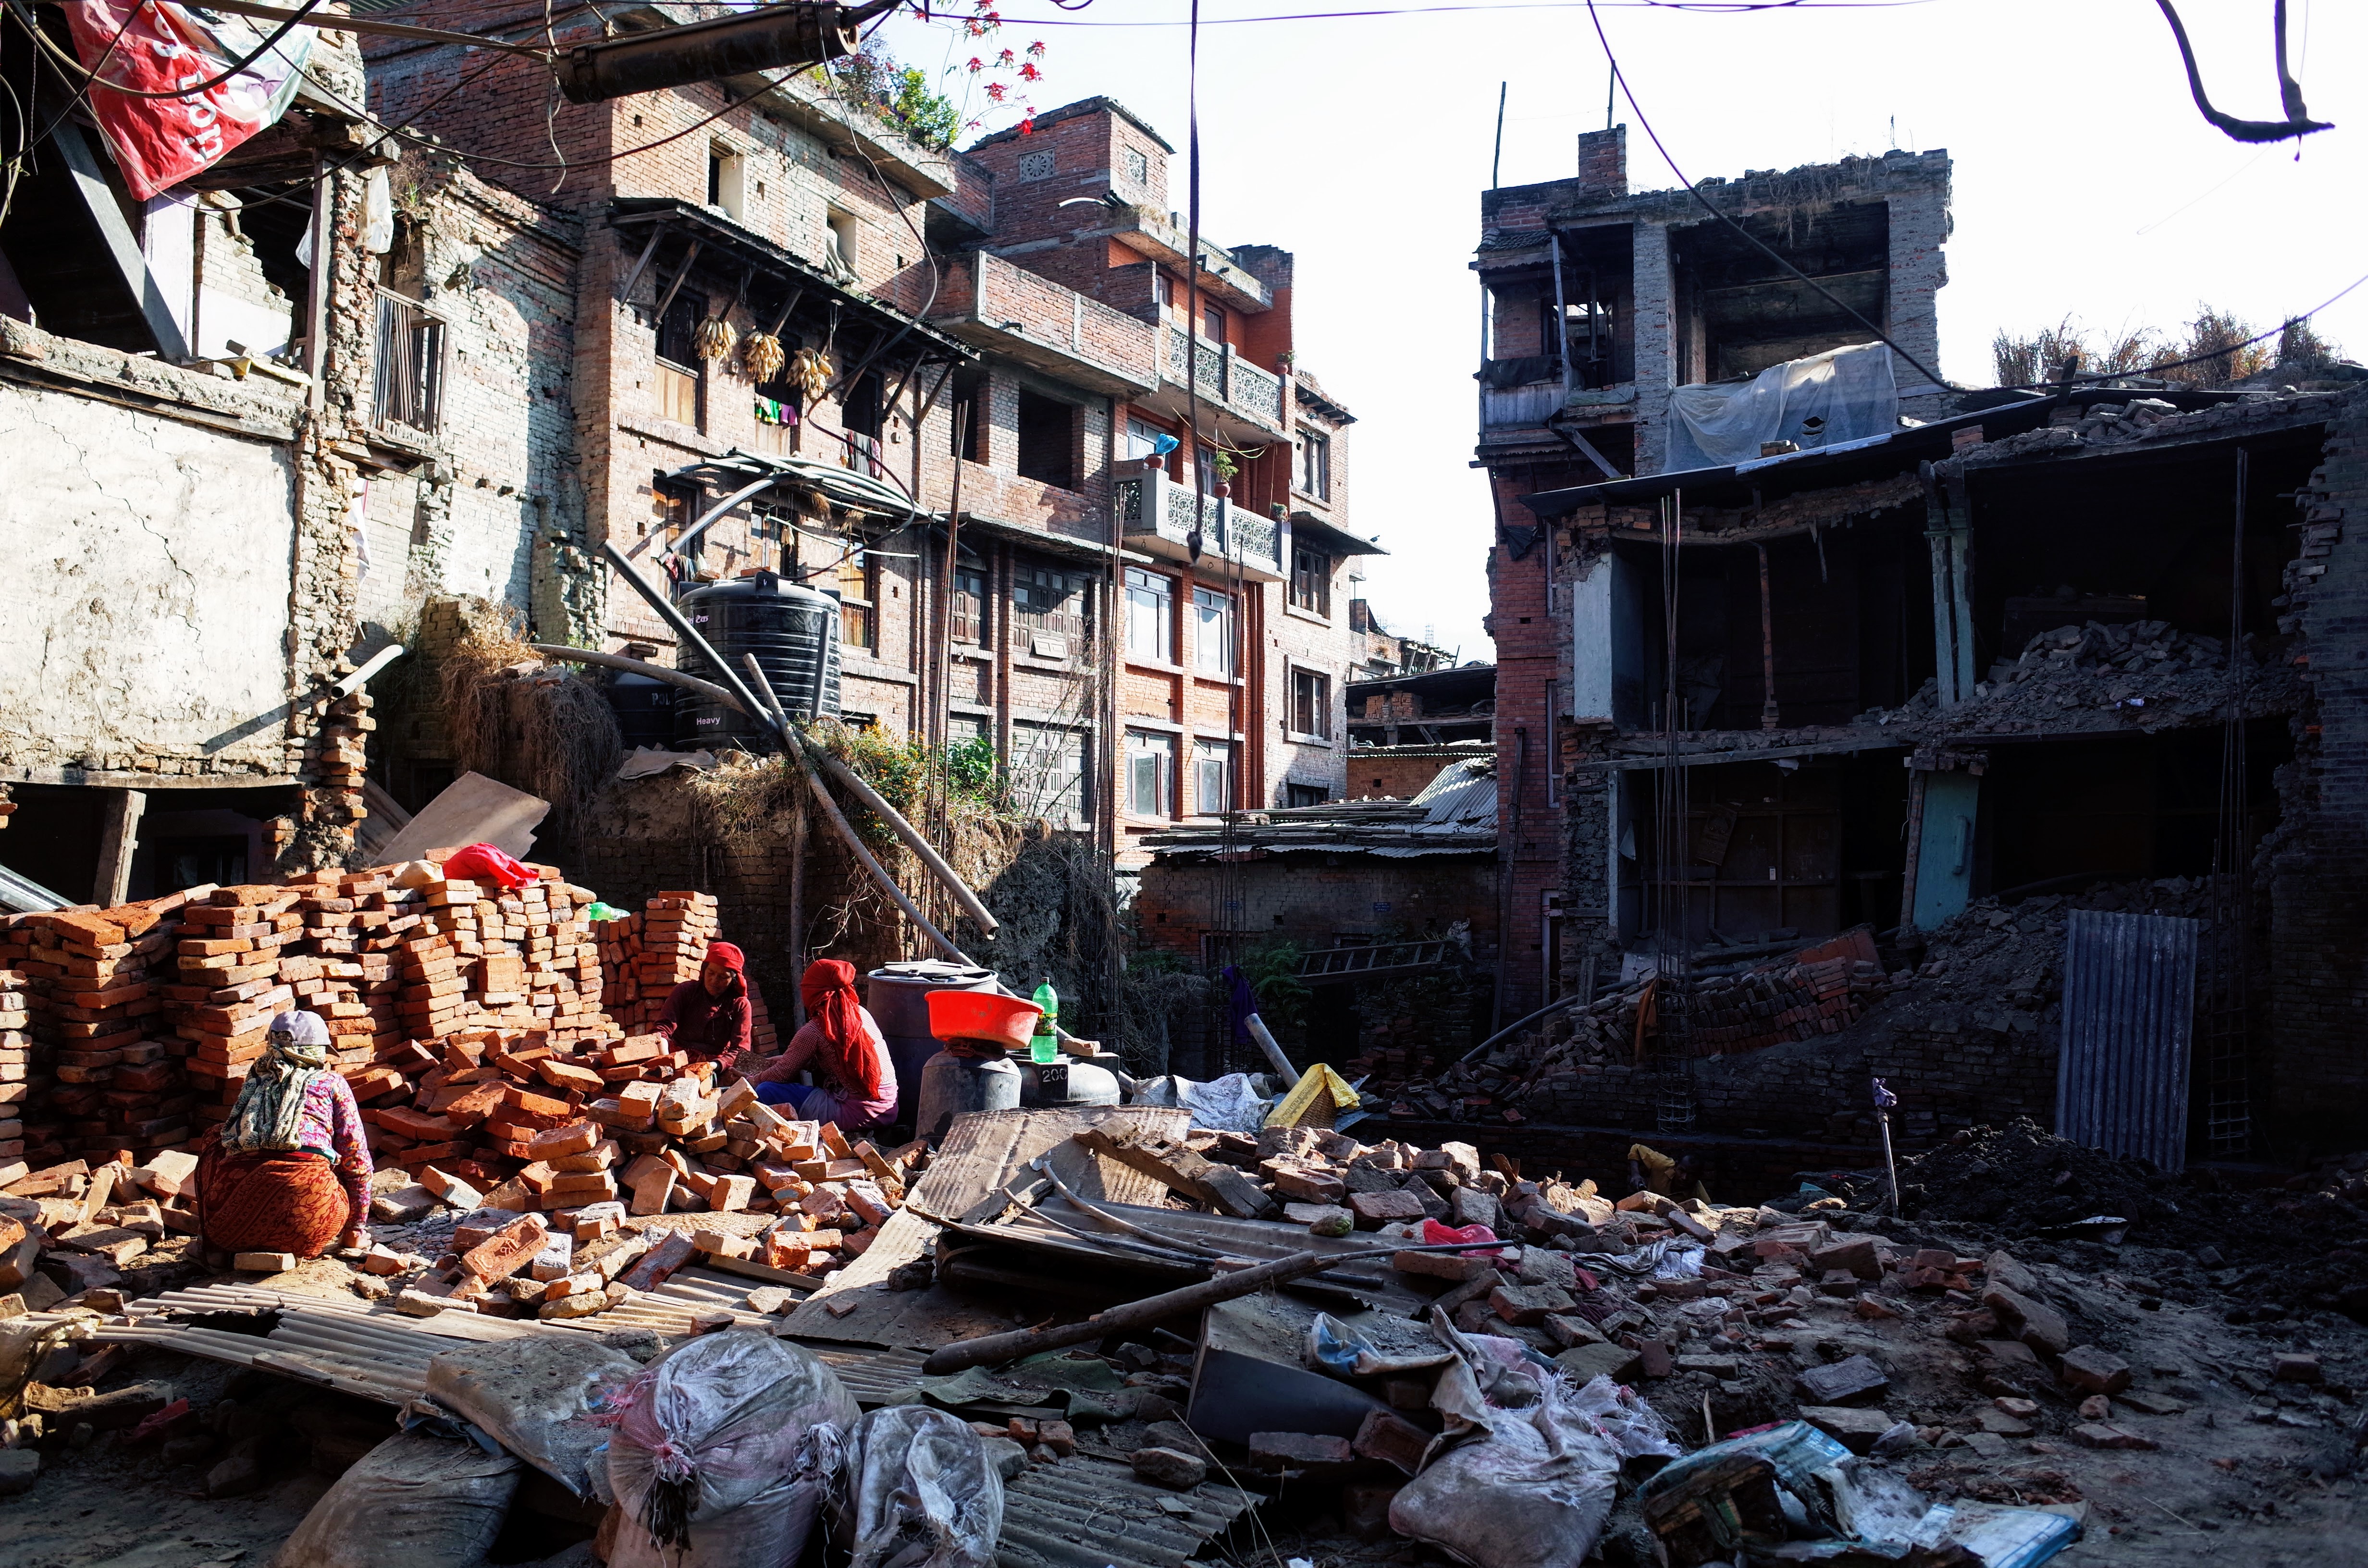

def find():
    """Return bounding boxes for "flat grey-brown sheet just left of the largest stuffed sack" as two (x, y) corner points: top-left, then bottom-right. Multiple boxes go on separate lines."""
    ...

(426, 1334), (640, 1497)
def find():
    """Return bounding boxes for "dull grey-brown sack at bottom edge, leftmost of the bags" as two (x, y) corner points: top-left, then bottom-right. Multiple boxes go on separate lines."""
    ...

(272, 1433), (526, 1568)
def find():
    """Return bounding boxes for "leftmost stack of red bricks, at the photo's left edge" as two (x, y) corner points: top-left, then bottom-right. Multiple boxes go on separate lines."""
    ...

(0, 893), (192, 1165)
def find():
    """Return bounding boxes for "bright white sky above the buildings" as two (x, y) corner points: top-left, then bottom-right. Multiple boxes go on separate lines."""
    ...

(888, 0), (2368, 659)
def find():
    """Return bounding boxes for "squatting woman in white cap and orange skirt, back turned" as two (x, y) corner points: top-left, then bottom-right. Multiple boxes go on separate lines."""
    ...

(197, 1011), (370, 1258)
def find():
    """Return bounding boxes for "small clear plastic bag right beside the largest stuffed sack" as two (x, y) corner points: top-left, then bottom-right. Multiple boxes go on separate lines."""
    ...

(834, 1405), (1004, 1568)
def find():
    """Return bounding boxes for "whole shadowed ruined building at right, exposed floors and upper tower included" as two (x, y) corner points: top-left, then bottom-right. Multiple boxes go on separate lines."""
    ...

(1449, 130), (2363, 1163)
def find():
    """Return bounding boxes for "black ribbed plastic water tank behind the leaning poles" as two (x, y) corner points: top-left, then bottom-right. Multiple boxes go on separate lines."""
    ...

(675, 571), (839, 751)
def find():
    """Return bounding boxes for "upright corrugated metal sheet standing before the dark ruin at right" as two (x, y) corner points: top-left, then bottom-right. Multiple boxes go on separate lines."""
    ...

(2056, 909), (2202, 1170)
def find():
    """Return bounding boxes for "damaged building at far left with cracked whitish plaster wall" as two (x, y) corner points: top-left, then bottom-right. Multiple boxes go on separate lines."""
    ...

(0, 19), (386, 907)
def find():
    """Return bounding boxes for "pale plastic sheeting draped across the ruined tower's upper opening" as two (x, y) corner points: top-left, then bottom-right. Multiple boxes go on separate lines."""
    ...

(1667, 343), (1899, 474)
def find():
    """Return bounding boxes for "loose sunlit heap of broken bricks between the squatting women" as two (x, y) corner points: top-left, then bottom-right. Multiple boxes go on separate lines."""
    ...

(355, 1075), (926, 1317)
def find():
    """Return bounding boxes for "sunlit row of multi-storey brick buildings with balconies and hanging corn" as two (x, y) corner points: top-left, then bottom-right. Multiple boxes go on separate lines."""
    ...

(358, 40), (1378, 865)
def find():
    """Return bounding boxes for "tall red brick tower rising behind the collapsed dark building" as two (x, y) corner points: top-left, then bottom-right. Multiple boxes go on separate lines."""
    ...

(1473, 125), (1949, 1021)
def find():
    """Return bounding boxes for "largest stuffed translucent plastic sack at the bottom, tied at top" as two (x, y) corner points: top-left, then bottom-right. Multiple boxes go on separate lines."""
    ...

(594, 1329), (857, 1568)
